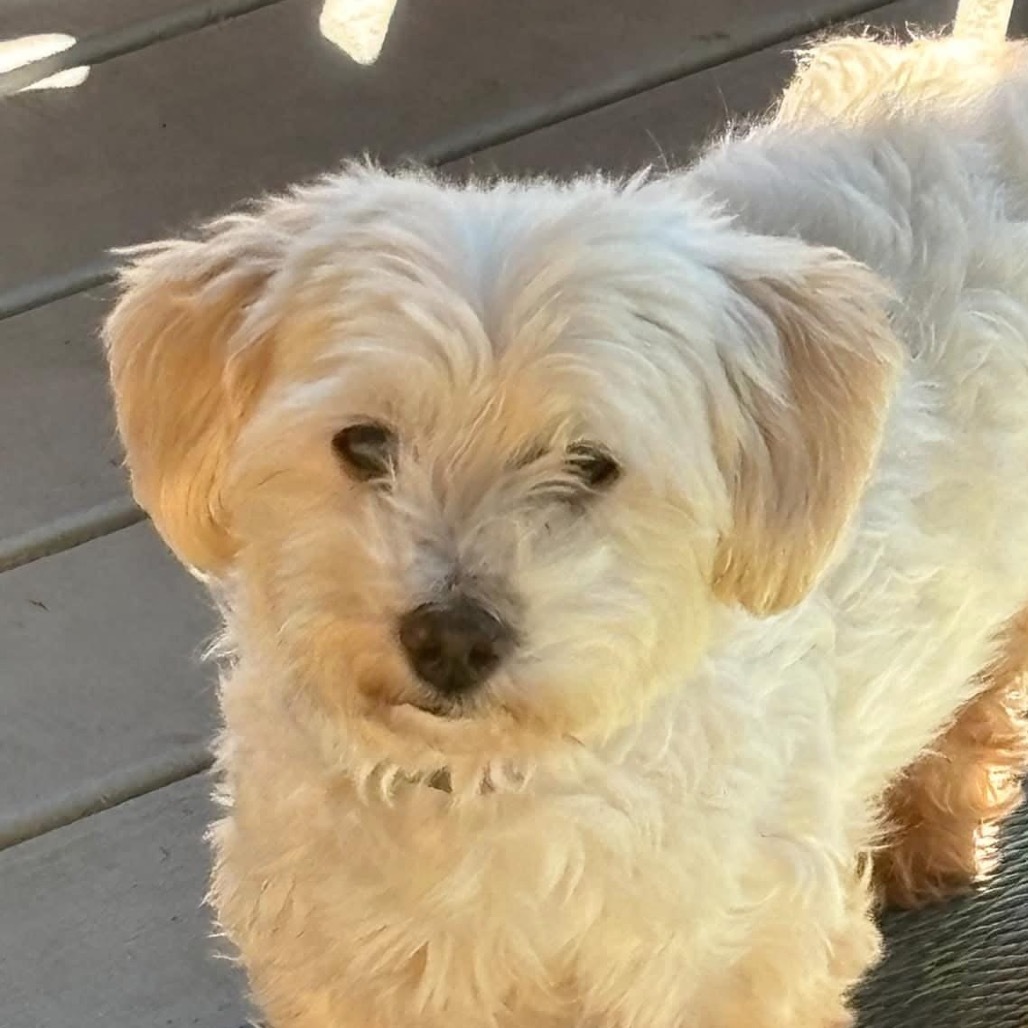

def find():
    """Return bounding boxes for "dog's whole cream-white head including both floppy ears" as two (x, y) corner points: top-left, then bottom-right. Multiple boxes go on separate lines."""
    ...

(106, 172), (897, 781)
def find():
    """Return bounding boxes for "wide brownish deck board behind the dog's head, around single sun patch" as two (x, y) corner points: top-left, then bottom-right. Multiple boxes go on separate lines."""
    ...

(0, 0), (888, 310)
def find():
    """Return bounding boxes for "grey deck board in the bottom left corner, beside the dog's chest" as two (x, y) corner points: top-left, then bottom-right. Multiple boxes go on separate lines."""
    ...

(0, 776), (248, 1028)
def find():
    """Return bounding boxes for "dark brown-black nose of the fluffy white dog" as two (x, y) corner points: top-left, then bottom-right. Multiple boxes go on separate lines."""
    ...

(400, 596), (514, 696)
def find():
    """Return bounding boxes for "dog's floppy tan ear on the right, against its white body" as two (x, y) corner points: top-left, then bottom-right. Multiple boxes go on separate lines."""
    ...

(712, 241), (902, 615)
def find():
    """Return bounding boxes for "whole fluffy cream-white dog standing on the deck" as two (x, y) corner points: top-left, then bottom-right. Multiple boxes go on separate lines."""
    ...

(106, 20), (1028, 1028)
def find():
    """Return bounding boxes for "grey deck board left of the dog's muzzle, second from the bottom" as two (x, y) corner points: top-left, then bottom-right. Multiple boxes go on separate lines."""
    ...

(0, 523), (215, 847)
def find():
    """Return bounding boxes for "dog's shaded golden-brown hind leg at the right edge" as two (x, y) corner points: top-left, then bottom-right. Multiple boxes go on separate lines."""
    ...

(875, 608), (1028, 907)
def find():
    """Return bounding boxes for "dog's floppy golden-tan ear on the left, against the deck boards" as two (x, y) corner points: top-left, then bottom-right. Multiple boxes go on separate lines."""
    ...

(104, 217), (281, 575)
